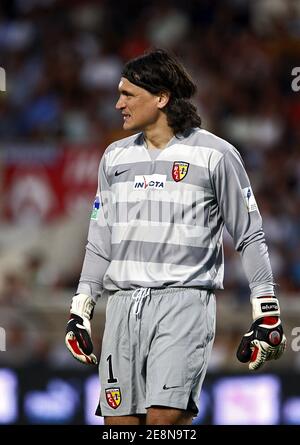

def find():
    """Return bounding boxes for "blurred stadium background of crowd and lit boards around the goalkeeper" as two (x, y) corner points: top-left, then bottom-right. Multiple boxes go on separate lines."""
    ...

(0, 0), (300, 424)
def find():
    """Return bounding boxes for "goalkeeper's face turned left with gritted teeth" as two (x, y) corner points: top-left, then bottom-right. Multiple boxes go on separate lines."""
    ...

(116, 77), (161, 130)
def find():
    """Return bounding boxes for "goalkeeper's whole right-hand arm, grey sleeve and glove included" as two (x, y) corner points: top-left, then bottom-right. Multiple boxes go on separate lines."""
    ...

(213, 148), (286, 370)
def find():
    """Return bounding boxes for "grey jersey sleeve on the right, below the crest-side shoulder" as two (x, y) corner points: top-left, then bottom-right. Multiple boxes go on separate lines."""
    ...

(212, 148), (274, 297)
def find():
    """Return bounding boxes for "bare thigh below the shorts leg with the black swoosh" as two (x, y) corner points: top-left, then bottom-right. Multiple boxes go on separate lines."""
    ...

(146, 406), (193, 425)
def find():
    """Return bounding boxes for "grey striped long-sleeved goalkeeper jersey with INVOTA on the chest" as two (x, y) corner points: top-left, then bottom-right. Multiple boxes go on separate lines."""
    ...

(77, 128), (274, 299)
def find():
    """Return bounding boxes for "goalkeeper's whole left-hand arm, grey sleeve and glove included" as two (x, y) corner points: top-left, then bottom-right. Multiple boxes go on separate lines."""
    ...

(65, 151), (112, 364)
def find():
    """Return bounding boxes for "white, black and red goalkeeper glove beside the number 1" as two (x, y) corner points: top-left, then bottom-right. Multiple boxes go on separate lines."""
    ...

(65, 294), (97, 365)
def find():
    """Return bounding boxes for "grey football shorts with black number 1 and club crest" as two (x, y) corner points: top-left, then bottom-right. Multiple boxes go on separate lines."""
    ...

(96, 287), (216, 416)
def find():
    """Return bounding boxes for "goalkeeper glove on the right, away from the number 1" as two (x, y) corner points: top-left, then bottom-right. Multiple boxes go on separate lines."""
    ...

(236, 297), (286, 371)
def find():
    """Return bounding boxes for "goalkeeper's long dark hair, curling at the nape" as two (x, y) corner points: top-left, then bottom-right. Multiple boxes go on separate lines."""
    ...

(122, 49), (201, 134)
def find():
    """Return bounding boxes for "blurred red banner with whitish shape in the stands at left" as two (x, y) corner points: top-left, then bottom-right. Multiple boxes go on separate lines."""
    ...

(1, 145), (103, 223)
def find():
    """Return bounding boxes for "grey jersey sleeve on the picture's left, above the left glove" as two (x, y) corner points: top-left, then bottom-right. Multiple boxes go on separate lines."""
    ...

(77, 151), (112, 301)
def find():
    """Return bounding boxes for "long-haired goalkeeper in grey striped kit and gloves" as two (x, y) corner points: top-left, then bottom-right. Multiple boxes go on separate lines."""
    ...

(66, 50), (286, 425)
